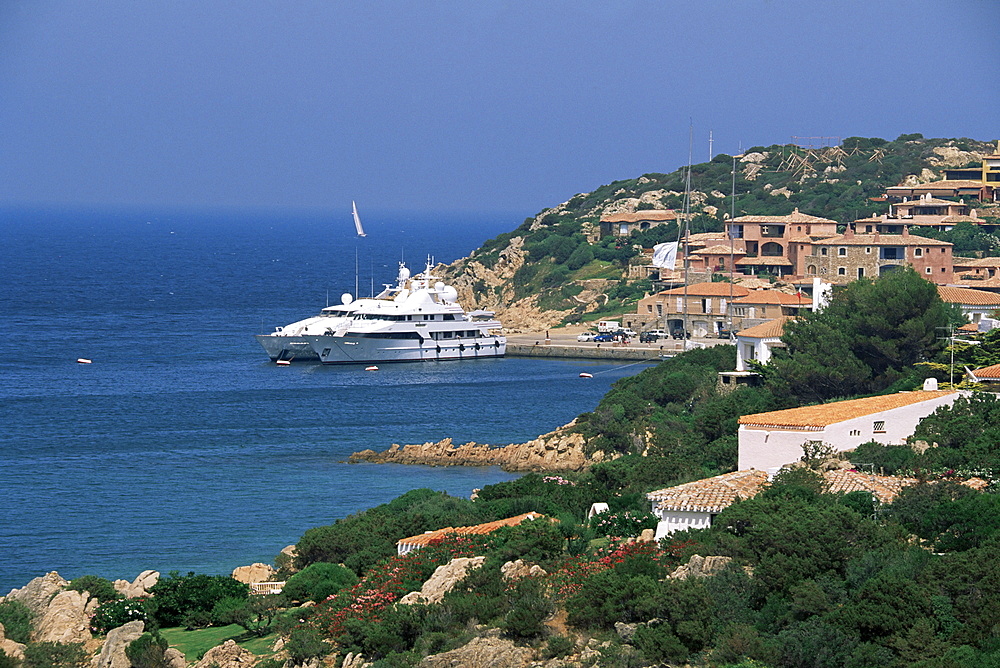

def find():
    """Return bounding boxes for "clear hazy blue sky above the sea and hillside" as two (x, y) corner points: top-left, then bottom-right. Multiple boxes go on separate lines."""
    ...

(0, 0), (1000, 216)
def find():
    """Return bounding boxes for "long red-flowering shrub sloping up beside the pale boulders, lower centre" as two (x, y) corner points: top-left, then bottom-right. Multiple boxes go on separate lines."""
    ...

(308, 535), (485, 640)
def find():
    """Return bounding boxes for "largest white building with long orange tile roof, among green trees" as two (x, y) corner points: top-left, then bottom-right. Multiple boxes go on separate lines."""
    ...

(739, 390), (959, 471)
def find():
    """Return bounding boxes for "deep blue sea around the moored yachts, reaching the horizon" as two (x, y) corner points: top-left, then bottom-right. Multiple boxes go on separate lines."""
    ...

(0, 207), (643, 594)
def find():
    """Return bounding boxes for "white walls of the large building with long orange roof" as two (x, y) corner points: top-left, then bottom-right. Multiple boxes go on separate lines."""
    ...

(737, 392), (958, 471)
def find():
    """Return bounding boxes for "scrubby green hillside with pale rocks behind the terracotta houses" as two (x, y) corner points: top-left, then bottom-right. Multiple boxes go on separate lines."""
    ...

(445, 134), (995, 331)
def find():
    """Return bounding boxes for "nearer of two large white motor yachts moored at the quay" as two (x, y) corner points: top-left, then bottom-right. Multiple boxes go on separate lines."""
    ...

(294, 260), (507, 364)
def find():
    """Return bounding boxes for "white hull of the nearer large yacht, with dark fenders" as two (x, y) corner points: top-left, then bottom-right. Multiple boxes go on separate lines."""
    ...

(304, 335), (507, 364)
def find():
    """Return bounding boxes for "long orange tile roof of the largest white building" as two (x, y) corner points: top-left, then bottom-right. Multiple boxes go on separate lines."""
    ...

(739, 390), (958, 431)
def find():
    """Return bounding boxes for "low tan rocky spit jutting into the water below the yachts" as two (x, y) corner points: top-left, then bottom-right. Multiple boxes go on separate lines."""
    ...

(350, 421), (606, 471)
